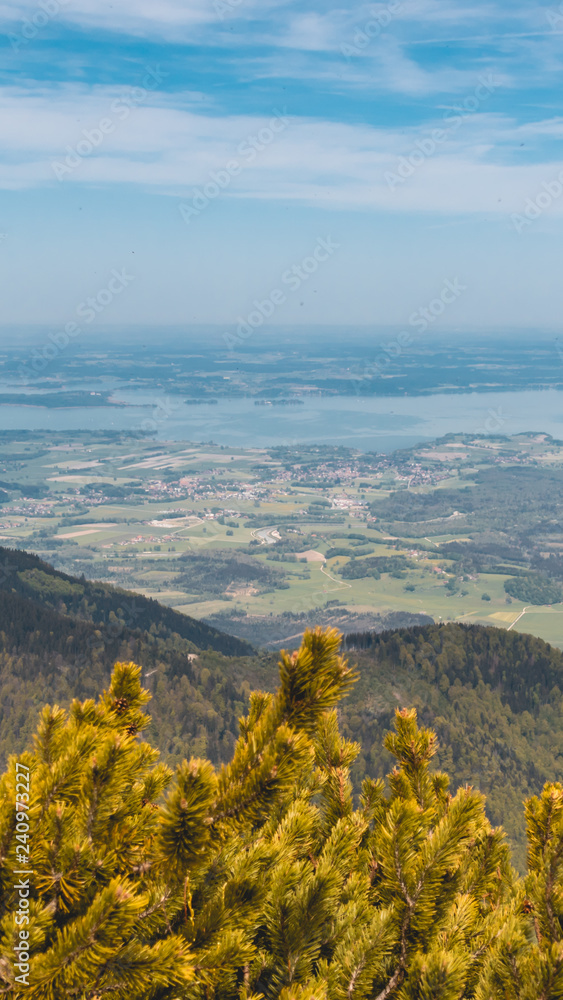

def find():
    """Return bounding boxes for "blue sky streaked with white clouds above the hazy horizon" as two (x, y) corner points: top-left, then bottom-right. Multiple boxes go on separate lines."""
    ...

(0, 0), (563, 343)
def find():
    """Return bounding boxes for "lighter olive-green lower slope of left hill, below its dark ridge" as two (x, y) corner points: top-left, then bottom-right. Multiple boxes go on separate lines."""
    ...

(0, 593), (268, 763)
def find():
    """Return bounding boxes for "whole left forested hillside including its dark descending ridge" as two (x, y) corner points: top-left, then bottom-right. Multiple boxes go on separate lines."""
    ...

(0, 549), (267, 764)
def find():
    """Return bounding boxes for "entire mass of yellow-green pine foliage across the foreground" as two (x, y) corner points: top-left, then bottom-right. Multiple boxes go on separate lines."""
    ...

(0, 630), (563, 1000)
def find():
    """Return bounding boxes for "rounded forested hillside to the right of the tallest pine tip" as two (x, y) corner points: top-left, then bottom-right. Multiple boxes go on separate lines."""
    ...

(340, 624), (563, 867)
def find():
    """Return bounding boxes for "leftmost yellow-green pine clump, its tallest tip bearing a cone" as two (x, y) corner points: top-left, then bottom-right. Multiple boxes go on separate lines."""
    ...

(0, 664), (193, 1000)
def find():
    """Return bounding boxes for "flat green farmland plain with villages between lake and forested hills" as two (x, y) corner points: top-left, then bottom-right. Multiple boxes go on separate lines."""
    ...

(0, 432), (563, 647)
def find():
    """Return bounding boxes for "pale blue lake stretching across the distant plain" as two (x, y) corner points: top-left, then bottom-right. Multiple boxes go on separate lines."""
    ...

(0, 385), (563, 452)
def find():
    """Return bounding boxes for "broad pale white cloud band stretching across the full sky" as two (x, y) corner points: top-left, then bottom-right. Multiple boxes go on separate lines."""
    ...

(0, 86), (563, 223)
